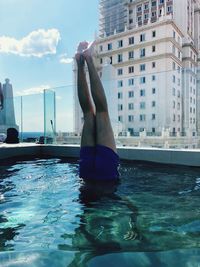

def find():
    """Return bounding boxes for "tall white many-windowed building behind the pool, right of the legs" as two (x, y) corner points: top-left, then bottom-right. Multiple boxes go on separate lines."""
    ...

(74, 0), (200, 135)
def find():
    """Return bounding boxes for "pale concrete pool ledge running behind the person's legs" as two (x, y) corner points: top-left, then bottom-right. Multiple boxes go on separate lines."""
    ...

(0, 143), (200, 167)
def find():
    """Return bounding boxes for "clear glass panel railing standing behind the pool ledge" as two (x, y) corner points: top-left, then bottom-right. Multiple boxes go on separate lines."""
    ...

(0, 67), (200, 149)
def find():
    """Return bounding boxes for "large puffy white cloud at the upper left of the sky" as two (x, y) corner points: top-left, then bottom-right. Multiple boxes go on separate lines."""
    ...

(0, 29), (61, 57)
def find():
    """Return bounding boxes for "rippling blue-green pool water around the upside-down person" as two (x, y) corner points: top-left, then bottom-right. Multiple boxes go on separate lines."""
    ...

(0, 159), (200, 267)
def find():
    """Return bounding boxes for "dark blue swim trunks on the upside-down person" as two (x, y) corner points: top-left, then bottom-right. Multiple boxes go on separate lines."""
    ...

(79, 145), (119, 180)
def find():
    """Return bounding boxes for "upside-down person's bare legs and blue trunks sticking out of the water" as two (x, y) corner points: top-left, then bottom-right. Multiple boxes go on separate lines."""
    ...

(75, 42), (119, 181)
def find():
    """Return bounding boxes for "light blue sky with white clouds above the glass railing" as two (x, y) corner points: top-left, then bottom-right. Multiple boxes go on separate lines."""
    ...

(0, 0), (98, 95)
